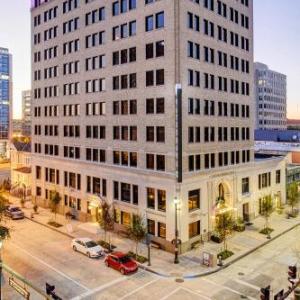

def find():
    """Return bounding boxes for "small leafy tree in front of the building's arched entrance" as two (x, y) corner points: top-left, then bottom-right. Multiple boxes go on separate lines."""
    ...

(215, 210), (235, 251)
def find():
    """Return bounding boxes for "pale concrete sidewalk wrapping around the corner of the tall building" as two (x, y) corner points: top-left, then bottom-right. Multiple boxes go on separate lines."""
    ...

(10, 196), (300, 278)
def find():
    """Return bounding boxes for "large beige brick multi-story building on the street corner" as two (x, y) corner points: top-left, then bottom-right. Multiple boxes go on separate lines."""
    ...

(32, 0), (285, 251)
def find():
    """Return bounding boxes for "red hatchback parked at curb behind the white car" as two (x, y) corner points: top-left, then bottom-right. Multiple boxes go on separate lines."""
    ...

(104, 252), (138, 275)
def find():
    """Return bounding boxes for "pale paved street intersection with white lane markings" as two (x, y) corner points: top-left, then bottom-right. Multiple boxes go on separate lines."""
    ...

(2, 219), (300, 300)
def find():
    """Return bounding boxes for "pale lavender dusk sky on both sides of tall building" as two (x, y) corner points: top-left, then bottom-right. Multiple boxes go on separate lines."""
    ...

(0, 0), (300, 119)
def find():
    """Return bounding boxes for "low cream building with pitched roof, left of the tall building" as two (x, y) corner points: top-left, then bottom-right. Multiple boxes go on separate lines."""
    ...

(10, 141), (32, 195)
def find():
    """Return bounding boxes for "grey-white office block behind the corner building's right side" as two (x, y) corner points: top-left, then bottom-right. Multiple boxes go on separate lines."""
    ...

(254, 63), (287, 130)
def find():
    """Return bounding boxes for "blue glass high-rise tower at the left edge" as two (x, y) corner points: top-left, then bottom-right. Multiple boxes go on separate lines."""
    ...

(0, 48), (12, 157)
